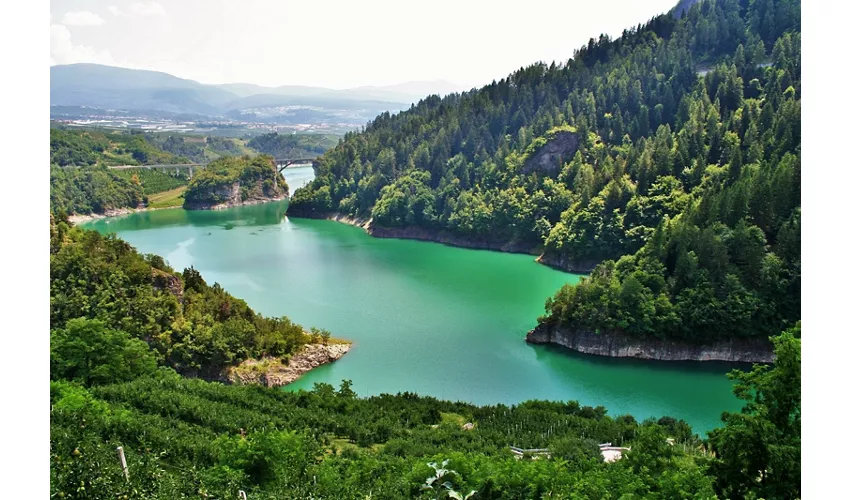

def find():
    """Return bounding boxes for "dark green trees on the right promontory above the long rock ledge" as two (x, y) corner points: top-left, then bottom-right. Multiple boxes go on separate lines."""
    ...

(546, 209), (800, 343)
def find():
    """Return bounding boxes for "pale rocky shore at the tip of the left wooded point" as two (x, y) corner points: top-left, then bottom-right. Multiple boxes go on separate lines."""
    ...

(224, 344), (351, 387)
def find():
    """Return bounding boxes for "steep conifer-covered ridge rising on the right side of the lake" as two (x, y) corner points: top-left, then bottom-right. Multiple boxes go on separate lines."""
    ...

(290, 0), (801, 350)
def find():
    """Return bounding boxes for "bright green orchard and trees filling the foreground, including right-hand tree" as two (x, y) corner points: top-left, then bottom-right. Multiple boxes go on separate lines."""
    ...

(50, 342), (800, 499)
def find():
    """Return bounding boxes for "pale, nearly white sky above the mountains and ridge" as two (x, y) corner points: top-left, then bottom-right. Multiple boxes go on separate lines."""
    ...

(50, 0), (676, 89)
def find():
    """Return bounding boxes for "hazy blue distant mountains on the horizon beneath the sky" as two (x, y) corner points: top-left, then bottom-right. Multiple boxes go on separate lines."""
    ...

(50, 64), (463, 118)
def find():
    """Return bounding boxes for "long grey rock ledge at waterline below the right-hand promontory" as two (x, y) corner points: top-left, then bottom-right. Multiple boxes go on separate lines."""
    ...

(525, 323), (774, 363)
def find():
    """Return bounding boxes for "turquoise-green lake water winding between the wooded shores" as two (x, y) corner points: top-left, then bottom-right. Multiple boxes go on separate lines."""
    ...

(81, 168), (741, 434)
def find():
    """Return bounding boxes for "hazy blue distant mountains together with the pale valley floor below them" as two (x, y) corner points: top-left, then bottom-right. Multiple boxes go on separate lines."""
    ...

(50, 64), (461, 133)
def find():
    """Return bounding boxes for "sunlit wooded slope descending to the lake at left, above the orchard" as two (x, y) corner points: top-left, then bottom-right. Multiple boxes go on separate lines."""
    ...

(50, 220), (322, 376)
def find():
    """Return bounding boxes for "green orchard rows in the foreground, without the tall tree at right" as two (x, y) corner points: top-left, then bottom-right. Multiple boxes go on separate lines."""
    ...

(51, 376), (712, 499)
